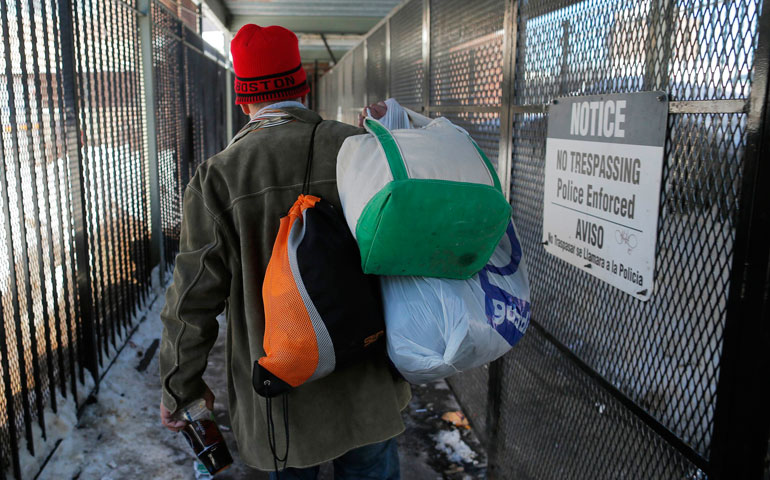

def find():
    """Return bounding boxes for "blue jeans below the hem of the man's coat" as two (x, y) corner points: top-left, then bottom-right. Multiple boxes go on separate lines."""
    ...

(270, 438), (401, 480)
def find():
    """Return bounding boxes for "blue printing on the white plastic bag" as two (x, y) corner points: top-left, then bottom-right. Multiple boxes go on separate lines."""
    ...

(479, 222), (530, 346)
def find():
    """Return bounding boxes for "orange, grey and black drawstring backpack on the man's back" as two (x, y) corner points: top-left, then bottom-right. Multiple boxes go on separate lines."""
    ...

(252, 120), (385, 471)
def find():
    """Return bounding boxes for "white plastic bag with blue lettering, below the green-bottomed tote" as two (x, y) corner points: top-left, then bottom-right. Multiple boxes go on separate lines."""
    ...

(381, 221), (530, 384)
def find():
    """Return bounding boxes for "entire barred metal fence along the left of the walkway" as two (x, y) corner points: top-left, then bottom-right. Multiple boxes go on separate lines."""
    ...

(0, 0), (232, 478)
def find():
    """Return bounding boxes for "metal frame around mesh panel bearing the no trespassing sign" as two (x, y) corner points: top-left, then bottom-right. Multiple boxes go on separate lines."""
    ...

(486, 0), (770, 480)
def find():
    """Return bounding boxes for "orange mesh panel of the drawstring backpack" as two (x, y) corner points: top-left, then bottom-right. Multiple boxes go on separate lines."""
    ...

(259, 195), (318, 387)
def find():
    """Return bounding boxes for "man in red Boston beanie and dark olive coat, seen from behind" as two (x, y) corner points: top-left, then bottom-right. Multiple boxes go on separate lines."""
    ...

(160, 25), (410, 479)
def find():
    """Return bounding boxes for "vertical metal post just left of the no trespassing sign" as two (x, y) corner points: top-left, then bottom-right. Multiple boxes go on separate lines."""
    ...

(486, 0), (519, 480)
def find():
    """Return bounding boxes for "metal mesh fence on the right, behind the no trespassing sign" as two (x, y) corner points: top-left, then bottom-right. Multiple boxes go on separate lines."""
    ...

(319, 0), (770, 478)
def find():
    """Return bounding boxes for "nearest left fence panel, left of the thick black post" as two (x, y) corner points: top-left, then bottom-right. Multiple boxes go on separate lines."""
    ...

(0, 0), (83, 476)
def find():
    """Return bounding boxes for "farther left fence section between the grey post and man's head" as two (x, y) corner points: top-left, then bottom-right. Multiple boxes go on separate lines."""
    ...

(152, 2), (231, 269)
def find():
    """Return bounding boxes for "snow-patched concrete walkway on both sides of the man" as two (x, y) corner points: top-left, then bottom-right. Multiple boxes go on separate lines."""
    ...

(38, 296), (486, 480)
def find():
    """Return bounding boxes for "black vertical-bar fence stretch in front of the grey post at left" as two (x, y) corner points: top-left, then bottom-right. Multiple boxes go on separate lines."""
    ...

(0, 0), (149, 477)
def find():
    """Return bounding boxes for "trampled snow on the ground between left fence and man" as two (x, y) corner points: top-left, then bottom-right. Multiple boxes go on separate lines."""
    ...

(39, 296), (192, 480)
